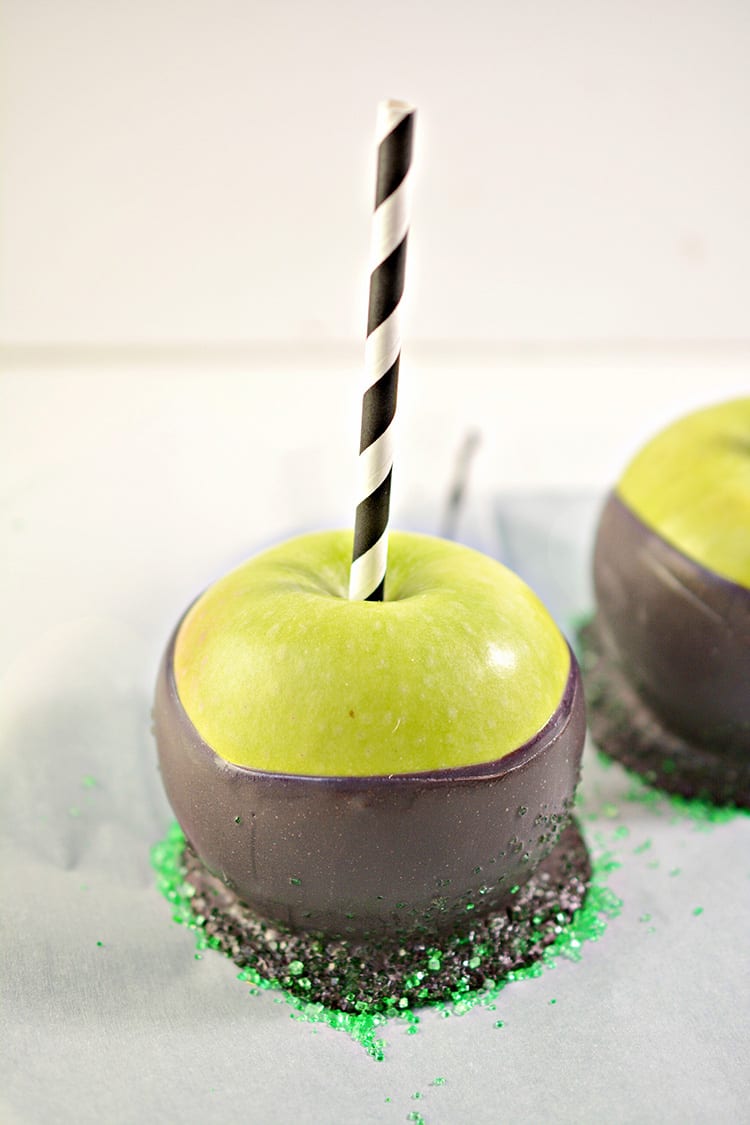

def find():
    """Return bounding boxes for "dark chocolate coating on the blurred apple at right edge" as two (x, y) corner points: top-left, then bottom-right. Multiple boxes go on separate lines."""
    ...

(594, 493), (750, 757)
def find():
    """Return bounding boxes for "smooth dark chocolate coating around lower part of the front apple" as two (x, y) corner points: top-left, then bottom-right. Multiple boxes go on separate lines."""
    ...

(154, 626), (586, 937)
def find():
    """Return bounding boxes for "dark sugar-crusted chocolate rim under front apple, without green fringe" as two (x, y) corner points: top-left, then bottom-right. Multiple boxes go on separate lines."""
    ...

(182, 822), (591, 1014)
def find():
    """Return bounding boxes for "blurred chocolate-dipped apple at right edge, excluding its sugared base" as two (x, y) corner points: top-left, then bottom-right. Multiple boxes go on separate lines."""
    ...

(594, 398), (750, 758)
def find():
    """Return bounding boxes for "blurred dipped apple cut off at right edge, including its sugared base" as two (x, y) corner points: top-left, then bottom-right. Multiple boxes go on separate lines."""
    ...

(584, 398), (750, 804)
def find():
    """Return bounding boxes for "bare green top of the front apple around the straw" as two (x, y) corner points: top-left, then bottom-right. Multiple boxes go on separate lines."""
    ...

(174, 531), (570, 776)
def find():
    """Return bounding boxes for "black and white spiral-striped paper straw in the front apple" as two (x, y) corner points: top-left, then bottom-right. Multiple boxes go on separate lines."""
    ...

(349, 101), (415, 602)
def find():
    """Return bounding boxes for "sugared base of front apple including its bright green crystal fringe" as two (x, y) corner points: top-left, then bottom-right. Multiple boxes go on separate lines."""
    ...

(152, 824), (622, 1057)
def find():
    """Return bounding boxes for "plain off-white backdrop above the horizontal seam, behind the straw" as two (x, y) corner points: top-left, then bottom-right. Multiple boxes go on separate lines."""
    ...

(0, 0), (750, 344)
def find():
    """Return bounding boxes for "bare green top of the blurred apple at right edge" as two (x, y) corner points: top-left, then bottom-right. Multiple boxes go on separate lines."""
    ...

(616, 398), (750, 586)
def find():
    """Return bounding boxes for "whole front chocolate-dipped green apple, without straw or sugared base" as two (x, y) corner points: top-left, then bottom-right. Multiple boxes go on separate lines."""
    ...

(154, 532), (585, 939)
